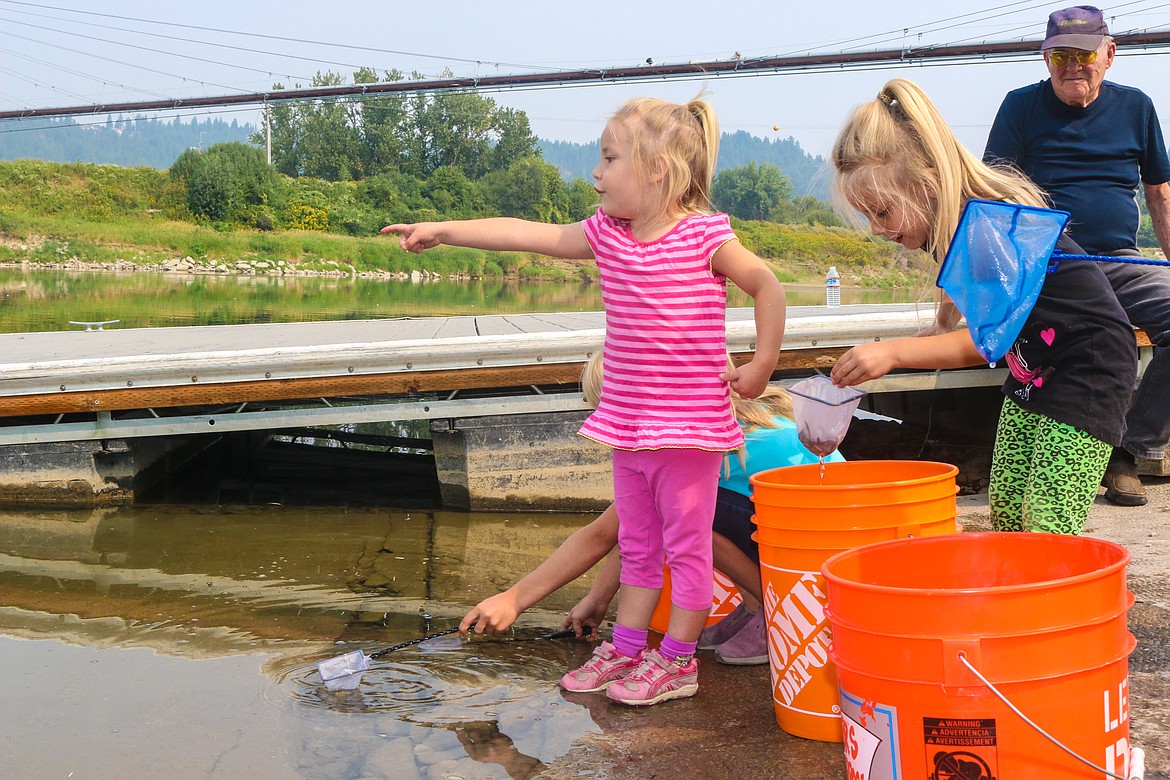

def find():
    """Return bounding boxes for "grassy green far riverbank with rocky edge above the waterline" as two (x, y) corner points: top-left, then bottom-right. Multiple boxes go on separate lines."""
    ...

(0, 160), (931, 288)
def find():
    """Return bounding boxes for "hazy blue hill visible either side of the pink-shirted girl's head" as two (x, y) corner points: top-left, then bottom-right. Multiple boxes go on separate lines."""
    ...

(541, 130), (830, 200)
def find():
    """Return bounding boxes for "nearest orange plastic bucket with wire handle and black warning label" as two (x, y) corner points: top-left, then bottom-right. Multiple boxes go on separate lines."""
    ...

(824, 533), (1135, 780)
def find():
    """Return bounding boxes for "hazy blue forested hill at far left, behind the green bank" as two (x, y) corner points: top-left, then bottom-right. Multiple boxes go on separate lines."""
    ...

(0, 117), (255, 170)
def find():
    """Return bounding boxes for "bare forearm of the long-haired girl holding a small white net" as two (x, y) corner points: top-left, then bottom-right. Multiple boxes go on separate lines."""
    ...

(830, 327), (986, 387)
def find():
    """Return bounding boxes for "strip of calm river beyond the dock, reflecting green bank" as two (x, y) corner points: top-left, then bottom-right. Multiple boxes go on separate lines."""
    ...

(0, 267), (932, 333)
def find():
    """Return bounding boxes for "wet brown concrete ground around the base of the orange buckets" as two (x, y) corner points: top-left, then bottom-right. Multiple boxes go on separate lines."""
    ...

(539, 477), (1170, 780)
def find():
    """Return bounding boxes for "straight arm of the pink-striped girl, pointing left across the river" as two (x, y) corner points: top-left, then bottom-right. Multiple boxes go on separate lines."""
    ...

(381, 216), (593, 260)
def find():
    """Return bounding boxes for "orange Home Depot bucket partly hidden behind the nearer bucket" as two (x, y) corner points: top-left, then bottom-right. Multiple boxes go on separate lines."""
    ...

(751, 461), (958, 741)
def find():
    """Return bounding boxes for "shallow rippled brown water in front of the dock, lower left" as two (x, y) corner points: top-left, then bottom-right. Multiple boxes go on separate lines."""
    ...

(0, 506), (600, 779)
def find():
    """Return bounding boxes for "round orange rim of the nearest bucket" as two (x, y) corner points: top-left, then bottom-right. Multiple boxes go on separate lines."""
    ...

(820, 531), (1130, 595)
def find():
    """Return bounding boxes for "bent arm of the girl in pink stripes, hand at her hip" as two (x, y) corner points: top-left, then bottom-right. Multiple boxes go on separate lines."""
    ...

(711, 241), (787, 398)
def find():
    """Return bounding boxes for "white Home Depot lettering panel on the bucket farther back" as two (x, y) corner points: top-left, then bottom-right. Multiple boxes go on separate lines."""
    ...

(764, 572), (840, 715)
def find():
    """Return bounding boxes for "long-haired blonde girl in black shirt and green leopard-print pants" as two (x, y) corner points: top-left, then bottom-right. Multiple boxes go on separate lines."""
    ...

(832, 78), (1136, 533)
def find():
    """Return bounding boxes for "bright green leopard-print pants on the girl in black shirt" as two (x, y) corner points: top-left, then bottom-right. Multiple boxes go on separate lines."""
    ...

(987, 398), (1113, 533)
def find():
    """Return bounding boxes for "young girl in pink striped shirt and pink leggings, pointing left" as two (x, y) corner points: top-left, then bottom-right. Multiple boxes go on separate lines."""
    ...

(383, 98), (785, 705)
